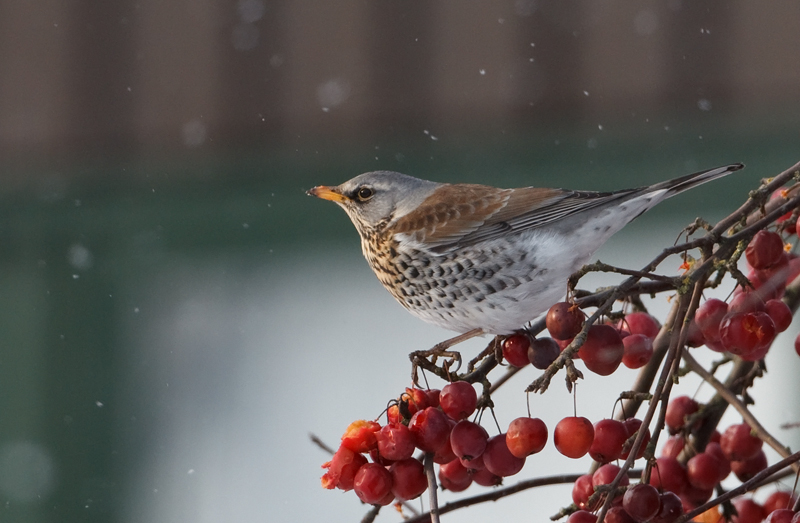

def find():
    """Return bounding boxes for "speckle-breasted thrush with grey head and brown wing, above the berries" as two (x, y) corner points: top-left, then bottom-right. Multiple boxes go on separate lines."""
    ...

(308, 164), (744, 334)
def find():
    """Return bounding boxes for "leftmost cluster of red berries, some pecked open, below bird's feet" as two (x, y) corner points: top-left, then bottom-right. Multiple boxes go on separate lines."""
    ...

(322, 381), (547, 505)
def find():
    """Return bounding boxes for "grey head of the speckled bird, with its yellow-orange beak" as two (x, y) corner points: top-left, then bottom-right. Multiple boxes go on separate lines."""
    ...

(308, 171), (442, 236)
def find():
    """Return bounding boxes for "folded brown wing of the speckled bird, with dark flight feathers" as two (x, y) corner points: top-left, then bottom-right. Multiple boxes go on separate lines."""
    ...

(392, 185), (635, 253)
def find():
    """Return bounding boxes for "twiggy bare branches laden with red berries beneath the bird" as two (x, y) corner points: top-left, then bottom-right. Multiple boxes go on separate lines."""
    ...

(322, 163), (800, 523)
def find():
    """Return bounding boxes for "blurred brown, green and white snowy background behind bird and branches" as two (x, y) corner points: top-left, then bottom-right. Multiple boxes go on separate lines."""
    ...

(0, 0), (800, 523)
